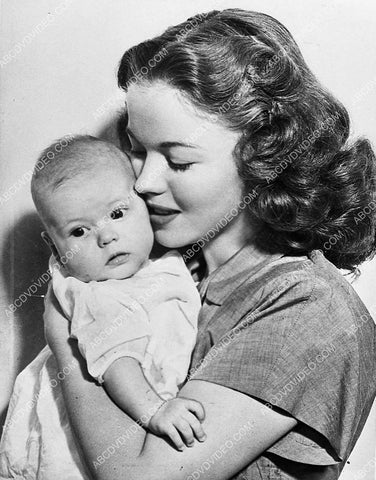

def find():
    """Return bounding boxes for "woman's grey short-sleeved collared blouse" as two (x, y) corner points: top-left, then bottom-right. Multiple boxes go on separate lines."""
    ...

(188, 245), (376, 480)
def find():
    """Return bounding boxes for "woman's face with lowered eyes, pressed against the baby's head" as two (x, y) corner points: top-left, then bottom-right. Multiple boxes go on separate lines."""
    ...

(127, 82), (249, 248)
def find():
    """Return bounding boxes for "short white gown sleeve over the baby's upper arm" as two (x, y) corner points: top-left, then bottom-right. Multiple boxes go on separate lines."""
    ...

(52, 256), (151, 383)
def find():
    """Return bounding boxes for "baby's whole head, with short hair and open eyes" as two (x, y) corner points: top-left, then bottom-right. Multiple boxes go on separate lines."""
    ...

(31, 136), (153, 282)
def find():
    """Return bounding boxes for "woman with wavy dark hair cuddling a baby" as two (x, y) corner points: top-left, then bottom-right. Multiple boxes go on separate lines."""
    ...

(46, 9), (376, 480)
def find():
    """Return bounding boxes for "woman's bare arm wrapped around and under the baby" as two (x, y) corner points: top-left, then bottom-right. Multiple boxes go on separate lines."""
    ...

(46, 288), (297, 480)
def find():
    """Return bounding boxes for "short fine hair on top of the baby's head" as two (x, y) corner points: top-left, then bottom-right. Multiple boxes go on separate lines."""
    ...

(31, 135), (134, 217)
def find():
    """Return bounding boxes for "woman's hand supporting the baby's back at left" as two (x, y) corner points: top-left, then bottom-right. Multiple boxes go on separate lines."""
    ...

(43, 283), (69, 356)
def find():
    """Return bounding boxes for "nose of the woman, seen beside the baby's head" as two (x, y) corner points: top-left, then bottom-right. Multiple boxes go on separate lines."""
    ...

(134, 157), (167, 194)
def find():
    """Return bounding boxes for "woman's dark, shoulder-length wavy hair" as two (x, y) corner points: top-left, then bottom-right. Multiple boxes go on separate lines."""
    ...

(118, 9), (376, 271)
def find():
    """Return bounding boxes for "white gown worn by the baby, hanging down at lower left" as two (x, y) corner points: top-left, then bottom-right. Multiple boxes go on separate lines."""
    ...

(0, 251), (201, 480)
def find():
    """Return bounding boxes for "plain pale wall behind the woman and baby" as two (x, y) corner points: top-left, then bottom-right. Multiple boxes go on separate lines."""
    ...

(0, 0), (376, 480)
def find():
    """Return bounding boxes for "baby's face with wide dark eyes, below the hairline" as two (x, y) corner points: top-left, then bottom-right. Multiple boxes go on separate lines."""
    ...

(46, 168), (153, 282)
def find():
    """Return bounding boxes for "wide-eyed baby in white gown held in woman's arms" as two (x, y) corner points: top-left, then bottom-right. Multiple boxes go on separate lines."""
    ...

(0, 136), (205, 479)
